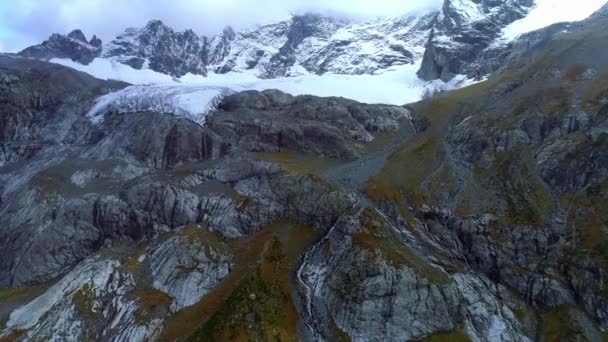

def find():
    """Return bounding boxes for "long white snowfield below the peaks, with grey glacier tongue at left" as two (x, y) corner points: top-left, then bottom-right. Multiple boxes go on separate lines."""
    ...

(51, 58), (472, 124)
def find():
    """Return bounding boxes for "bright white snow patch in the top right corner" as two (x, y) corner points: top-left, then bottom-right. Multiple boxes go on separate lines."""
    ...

(503, 0), (606, 40)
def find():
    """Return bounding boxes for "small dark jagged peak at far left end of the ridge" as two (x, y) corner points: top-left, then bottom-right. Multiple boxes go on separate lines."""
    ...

(19, 30), (102, 64)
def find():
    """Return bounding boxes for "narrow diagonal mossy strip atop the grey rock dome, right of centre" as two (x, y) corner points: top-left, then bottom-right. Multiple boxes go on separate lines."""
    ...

(352, 208), (449, 284)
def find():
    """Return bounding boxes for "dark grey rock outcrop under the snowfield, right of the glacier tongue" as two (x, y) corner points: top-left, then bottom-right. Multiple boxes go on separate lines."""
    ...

(207, 90), (409, 159)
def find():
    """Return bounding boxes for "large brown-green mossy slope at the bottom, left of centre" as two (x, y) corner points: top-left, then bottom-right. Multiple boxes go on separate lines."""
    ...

(161, 222), (318, 341)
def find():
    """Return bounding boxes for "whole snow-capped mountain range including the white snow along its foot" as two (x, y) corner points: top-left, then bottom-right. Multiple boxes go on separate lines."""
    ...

(15, 0), (599, 95)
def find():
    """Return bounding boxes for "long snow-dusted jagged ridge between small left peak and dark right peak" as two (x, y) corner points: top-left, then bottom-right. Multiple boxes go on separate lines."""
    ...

(103, 14), (432, 78)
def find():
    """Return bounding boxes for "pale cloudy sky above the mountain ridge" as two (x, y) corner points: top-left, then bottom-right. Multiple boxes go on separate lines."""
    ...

(0, 0), (443, 52)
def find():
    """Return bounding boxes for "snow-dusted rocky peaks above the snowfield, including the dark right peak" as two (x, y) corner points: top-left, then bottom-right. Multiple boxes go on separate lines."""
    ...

(14, 0), (533, 81)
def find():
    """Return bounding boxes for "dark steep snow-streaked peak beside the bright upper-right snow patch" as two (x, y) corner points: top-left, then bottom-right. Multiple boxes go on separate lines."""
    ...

(418, 0), (534, 80)
